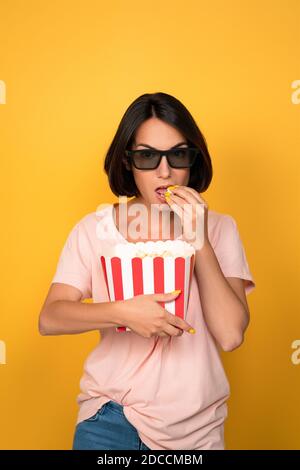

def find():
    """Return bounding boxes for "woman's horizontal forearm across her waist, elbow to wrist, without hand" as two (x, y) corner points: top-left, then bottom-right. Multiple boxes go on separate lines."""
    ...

(39, 300), (125, 335)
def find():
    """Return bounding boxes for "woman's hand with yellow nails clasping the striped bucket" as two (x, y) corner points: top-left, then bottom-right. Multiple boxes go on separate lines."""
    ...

(118, 291), (193, 338)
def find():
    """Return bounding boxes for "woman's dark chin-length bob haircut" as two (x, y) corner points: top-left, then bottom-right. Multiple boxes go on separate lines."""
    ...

(104, 92), (213, 197)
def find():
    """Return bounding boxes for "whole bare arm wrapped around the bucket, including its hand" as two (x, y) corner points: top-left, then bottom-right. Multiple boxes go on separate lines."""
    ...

(39, 282), (193, 338)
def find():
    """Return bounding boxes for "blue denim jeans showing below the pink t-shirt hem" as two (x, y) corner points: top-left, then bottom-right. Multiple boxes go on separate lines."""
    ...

(73, 401), (151, 450)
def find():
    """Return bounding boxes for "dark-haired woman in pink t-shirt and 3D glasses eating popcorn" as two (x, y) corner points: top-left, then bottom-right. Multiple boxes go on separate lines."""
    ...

(39, 93), (255, 450)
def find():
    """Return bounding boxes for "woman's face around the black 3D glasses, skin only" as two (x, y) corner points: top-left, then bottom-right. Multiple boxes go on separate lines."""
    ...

(132, 117), (190, 206)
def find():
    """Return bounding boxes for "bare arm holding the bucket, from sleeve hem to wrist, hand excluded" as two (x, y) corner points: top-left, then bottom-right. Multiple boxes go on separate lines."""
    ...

(39, 283), (123, 335)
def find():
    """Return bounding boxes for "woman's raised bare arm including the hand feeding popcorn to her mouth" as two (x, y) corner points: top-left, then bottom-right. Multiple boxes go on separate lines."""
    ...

(166, 186), (249, 351)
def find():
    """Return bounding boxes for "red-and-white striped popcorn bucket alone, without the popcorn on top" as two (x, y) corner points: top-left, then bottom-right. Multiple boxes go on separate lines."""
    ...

(101, 254), (195, 331)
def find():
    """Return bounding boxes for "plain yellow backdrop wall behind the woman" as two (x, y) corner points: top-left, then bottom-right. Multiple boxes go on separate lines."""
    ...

(0, 0), (300, 449)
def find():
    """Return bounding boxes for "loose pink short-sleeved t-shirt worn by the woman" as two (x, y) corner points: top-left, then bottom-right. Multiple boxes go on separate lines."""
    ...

(52, 204), (255, 450)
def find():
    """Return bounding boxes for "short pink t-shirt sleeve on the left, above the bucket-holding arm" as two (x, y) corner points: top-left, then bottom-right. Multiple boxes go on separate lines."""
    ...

(52, 221), (92, 299)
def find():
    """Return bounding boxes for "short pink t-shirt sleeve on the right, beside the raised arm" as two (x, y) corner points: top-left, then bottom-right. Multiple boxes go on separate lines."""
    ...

(214, 214), (256, 294)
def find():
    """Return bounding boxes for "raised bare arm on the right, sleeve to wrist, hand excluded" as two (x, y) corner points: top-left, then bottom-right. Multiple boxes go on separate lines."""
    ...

(195, 243), (249, 351)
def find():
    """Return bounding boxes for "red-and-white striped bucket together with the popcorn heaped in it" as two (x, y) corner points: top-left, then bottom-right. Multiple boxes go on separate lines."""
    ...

(101, 240), (195, 331)
